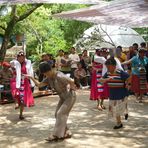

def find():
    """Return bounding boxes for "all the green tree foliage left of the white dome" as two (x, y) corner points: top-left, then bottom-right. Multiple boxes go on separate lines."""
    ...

(0, 4), (90, 61)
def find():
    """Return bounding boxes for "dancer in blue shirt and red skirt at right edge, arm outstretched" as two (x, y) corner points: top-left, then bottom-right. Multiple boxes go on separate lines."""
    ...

(122, 48), (148, 103)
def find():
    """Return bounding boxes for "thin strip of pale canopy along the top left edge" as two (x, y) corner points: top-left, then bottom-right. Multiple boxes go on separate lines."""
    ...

(0, 0), (104, 4)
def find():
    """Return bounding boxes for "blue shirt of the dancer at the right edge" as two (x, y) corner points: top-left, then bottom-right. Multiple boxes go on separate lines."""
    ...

(131, 55), (148, 75)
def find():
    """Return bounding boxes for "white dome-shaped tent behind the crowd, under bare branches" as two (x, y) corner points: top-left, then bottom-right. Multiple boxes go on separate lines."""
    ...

(76, 25), (145, 48)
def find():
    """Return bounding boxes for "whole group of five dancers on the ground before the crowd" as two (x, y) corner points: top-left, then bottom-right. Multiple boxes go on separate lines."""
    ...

(1, 43), (148, 142)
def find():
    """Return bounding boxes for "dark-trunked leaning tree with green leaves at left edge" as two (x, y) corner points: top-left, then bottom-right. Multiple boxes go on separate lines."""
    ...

(0, 4), (42, 62)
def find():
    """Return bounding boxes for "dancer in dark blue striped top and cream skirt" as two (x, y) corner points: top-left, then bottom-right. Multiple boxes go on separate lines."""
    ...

(100, 57), (129, 129)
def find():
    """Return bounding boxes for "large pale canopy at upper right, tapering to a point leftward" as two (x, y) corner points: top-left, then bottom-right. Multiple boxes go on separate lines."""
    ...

(54, 0), (148, 27)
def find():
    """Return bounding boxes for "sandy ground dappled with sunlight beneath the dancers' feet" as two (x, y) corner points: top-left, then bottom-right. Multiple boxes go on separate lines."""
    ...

(0, 90), (148, 148)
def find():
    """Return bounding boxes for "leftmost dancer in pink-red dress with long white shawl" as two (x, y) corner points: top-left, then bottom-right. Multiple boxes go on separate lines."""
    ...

(10, 51), (34, 120)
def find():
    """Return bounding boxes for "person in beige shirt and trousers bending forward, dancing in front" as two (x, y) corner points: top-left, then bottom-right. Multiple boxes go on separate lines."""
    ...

(26, 62), (76, 142)
